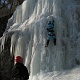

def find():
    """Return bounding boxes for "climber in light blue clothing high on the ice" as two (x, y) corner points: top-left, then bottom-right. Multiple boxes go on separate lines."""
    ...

(45, 20), (56, 47)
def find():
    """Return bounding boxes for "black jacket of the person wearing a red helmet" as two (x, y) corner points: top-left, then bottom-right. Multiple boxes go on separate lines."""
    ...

(12, 63), (29, 80)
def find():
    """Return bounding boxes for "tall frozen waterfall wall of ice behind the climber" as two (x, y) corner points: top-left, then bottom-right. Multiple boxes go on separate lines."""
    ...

(1, 0), (80, 76)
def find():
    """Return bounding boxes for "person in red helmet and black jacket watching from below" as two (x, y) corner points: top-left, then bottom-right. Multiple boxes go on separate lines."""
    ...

(12, 56), (29, 80)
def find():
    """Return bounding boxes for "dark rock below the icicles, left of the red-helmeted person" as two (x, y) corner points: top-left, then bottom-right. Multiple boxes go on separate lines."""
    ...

(0, 39), (13, 80)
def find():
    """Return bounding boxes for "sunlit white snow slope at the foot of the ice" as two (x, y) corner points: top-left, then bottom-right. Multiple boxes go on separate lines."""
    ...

(30, 66), (80, 80)
